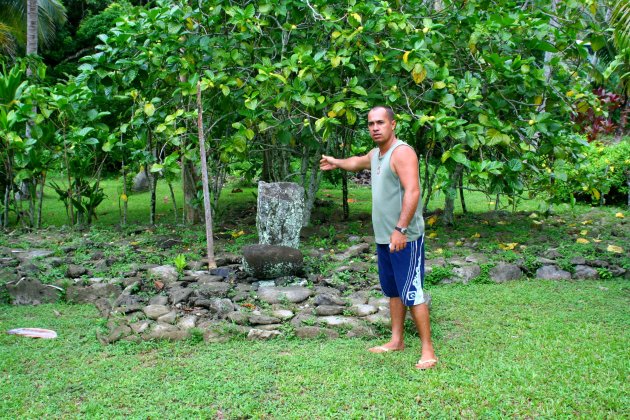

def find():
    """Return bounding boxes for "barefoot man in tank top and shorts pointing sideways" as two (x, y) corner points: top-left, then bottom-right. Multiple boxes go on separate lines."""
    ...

(320, 106), (437, 370)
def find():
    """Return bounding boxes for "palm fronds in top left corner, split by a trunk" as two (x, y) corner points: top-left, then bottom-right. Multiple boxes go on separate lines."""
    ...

(0, 0), (66, 56)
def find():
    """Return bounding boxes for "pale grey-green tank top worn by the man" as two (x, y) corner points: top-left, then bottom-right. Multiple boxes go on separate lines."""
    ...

(371, 140), (424, 245)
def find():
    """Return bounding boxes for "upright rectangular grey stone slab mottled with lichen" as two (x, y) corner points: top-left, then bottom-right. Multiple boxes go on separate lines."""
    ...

(256, 181), (304, 249)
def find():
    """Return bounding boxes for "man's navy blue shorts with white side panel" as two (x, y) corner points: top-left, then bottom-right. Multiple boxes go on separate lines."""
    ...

(376, 235), (425, 306)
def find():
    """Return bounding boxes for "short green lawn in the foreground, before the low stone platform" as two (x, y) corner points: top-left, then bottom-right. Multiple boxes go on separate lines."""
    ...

(0, 280), (630, 418)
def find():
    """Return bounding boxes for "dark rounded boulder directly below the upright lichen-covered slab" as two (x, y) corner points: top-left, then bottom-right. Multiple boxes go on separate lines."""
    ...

(243, 244), (304, 279)
